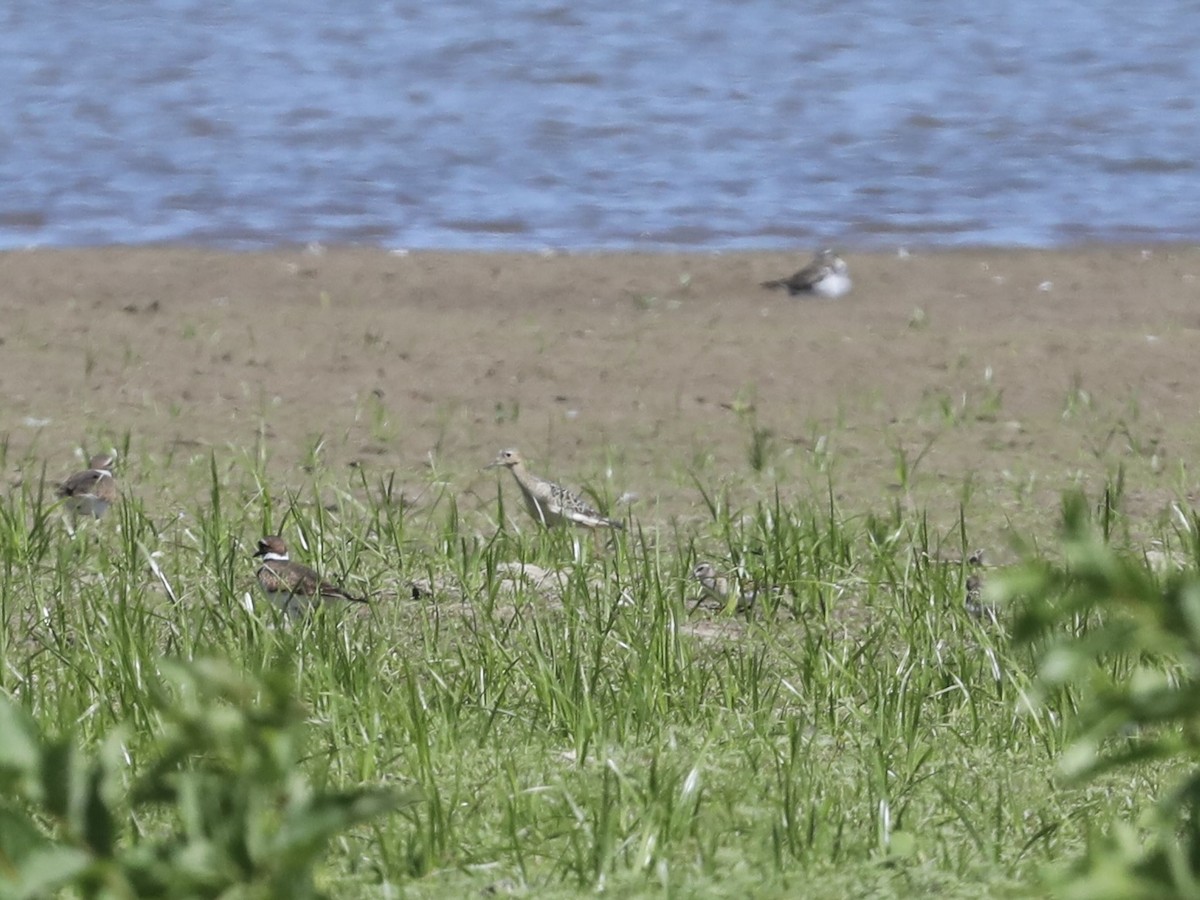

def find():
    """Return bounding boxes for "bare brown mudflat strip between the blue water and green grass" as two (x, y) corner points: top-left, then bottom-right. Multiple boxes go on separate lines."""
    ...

(0, 246), (1200, 532)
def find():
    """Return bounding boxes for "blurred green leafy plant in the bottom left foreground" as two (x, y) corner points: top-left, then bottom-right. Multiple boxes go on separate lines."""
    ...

(0, 661), (402, 898)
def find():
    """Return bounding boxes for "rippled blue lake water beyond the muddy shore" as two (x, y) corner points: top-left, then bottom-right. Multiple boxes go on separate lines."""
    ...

(0, 0), (1200, 251)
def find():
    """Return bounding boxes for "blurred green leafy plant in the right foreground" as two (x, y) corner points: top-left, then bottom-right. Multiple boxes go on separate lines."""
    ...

(1000, 494), (1200, 898)
